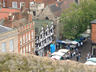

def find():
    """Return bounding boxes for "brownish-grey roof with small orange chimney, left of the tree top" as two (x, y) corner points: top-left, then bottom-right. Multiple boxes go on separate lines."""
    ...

(49, 0), (73, 16)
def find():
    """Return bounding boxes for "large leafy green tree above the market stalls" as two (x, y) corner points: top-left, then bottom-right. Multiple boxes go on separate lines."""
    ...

(60, 0), (96, 39)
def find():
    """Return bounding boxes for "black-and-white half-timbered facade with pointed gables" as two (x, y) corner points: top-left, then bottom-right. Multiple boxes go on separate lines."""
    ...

(35, 19), (54, 56)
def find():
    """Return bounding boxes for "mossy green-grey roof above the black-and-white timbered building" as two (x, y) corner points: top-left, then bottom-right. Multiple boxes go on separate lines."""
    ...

(33, 20), (53, 35)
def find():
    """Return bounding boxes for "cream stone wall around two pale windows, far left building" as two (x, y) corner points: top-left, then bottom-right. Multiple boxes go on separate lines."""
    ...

(0, 30), (18, 53)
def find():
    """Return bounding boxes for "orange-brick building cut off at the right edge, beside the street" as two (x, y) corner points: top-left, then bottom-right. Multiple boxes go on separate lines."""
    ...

(91, 19), (96, 56)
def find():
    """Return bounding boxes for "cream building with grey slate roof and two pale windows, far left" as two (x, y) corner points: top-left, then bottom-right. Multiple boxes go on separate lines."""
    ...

(0, 25), (18, 53)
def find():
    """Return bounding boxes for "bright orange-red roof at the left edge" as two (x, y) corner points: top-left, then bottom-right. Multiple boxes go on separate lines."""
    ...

(0, 8), (20, 20)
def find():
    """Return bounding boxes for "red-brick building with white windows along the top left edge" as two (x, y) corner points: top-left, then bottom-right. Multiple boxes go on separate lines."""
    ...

(0, 0), (57, 8)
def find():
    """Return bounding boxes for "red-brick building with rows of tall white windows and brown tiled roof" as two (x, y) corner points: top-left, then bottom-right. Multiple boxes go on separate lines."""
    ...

(1, 9), (35, 54)
